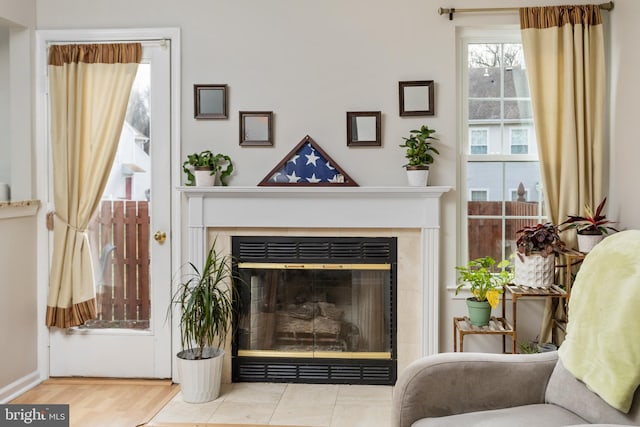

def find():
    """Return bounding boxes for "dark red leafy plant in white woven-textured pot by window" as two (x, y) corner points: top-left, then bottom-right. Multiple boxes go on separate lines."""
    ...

(514, 222), (565, 288)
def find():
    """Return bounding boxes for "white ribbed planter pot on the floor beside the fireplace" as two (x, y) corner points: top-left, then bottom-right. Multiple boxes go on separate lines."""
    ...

(178, 347), (224, 403)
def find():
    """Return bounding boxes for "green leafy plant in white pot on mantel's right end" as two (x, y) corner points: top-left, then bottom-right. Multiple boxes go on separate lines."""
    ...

(400, 125), (440, 187)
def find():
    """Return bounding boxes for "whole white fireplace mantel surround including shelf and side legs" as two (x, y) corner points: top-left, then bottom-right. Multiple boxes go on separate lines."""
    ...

(178, 186), (451, 355)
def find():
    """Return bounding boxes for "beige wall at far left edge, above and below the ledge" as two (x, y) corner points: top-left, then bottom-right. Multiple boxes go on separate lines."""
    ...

(0, 0), (38, 401)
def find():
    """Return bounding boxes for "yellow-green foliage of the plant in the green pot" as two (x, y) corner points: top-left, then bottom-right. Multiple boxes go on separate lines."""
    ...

(456, 256), (513, 308)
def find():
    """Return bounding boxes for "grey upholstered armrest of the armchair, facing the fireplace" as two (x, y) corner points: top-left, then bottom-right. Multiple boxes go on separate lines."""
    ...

(391, 352), (558, 427)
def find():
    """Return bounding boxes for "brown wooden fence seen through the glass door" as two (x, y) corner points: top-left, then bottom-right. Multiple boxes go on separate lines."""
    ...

(89, 200), (150, 327)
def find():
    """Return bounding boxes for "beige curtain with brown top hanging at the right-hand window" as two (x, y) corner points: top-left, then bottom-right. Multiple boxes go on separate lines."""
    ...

(520, 5), (606, 342)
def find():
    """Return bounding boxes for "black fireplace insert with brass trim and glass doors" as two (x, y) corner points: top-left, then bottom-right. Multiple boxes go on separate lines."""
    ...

(232, 236), (397, 384)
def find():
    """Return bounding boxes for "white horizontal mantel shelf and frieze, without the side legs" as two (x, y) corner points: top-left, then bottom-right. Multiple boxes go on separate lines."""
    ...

(178, 186), (451, 228)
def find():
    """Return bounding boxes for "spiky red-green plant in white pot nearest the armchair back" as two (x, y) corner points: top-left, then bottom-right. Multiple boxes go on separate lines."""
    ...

(560, 197), (618, 253)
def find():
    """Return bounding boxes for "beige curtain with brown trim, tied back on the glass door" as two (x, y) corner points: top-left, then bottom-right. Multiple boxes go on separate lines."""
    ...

(46, 43), (142, 328)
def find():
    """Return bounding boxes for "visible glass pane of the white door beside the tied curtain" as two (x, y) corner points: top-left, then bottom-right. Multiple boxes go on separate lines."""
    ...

(84, 64), (151, 329)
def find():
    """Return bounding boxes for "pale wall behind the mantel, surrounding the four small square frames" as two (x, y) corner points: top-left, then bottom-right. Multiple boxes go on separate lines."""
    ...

(37, 0), (640, 360)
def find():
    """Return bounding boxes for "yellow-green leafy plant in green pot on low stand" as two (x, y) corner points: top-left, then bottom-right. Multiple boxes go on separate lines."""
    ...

(456, 256), (513, 326)
